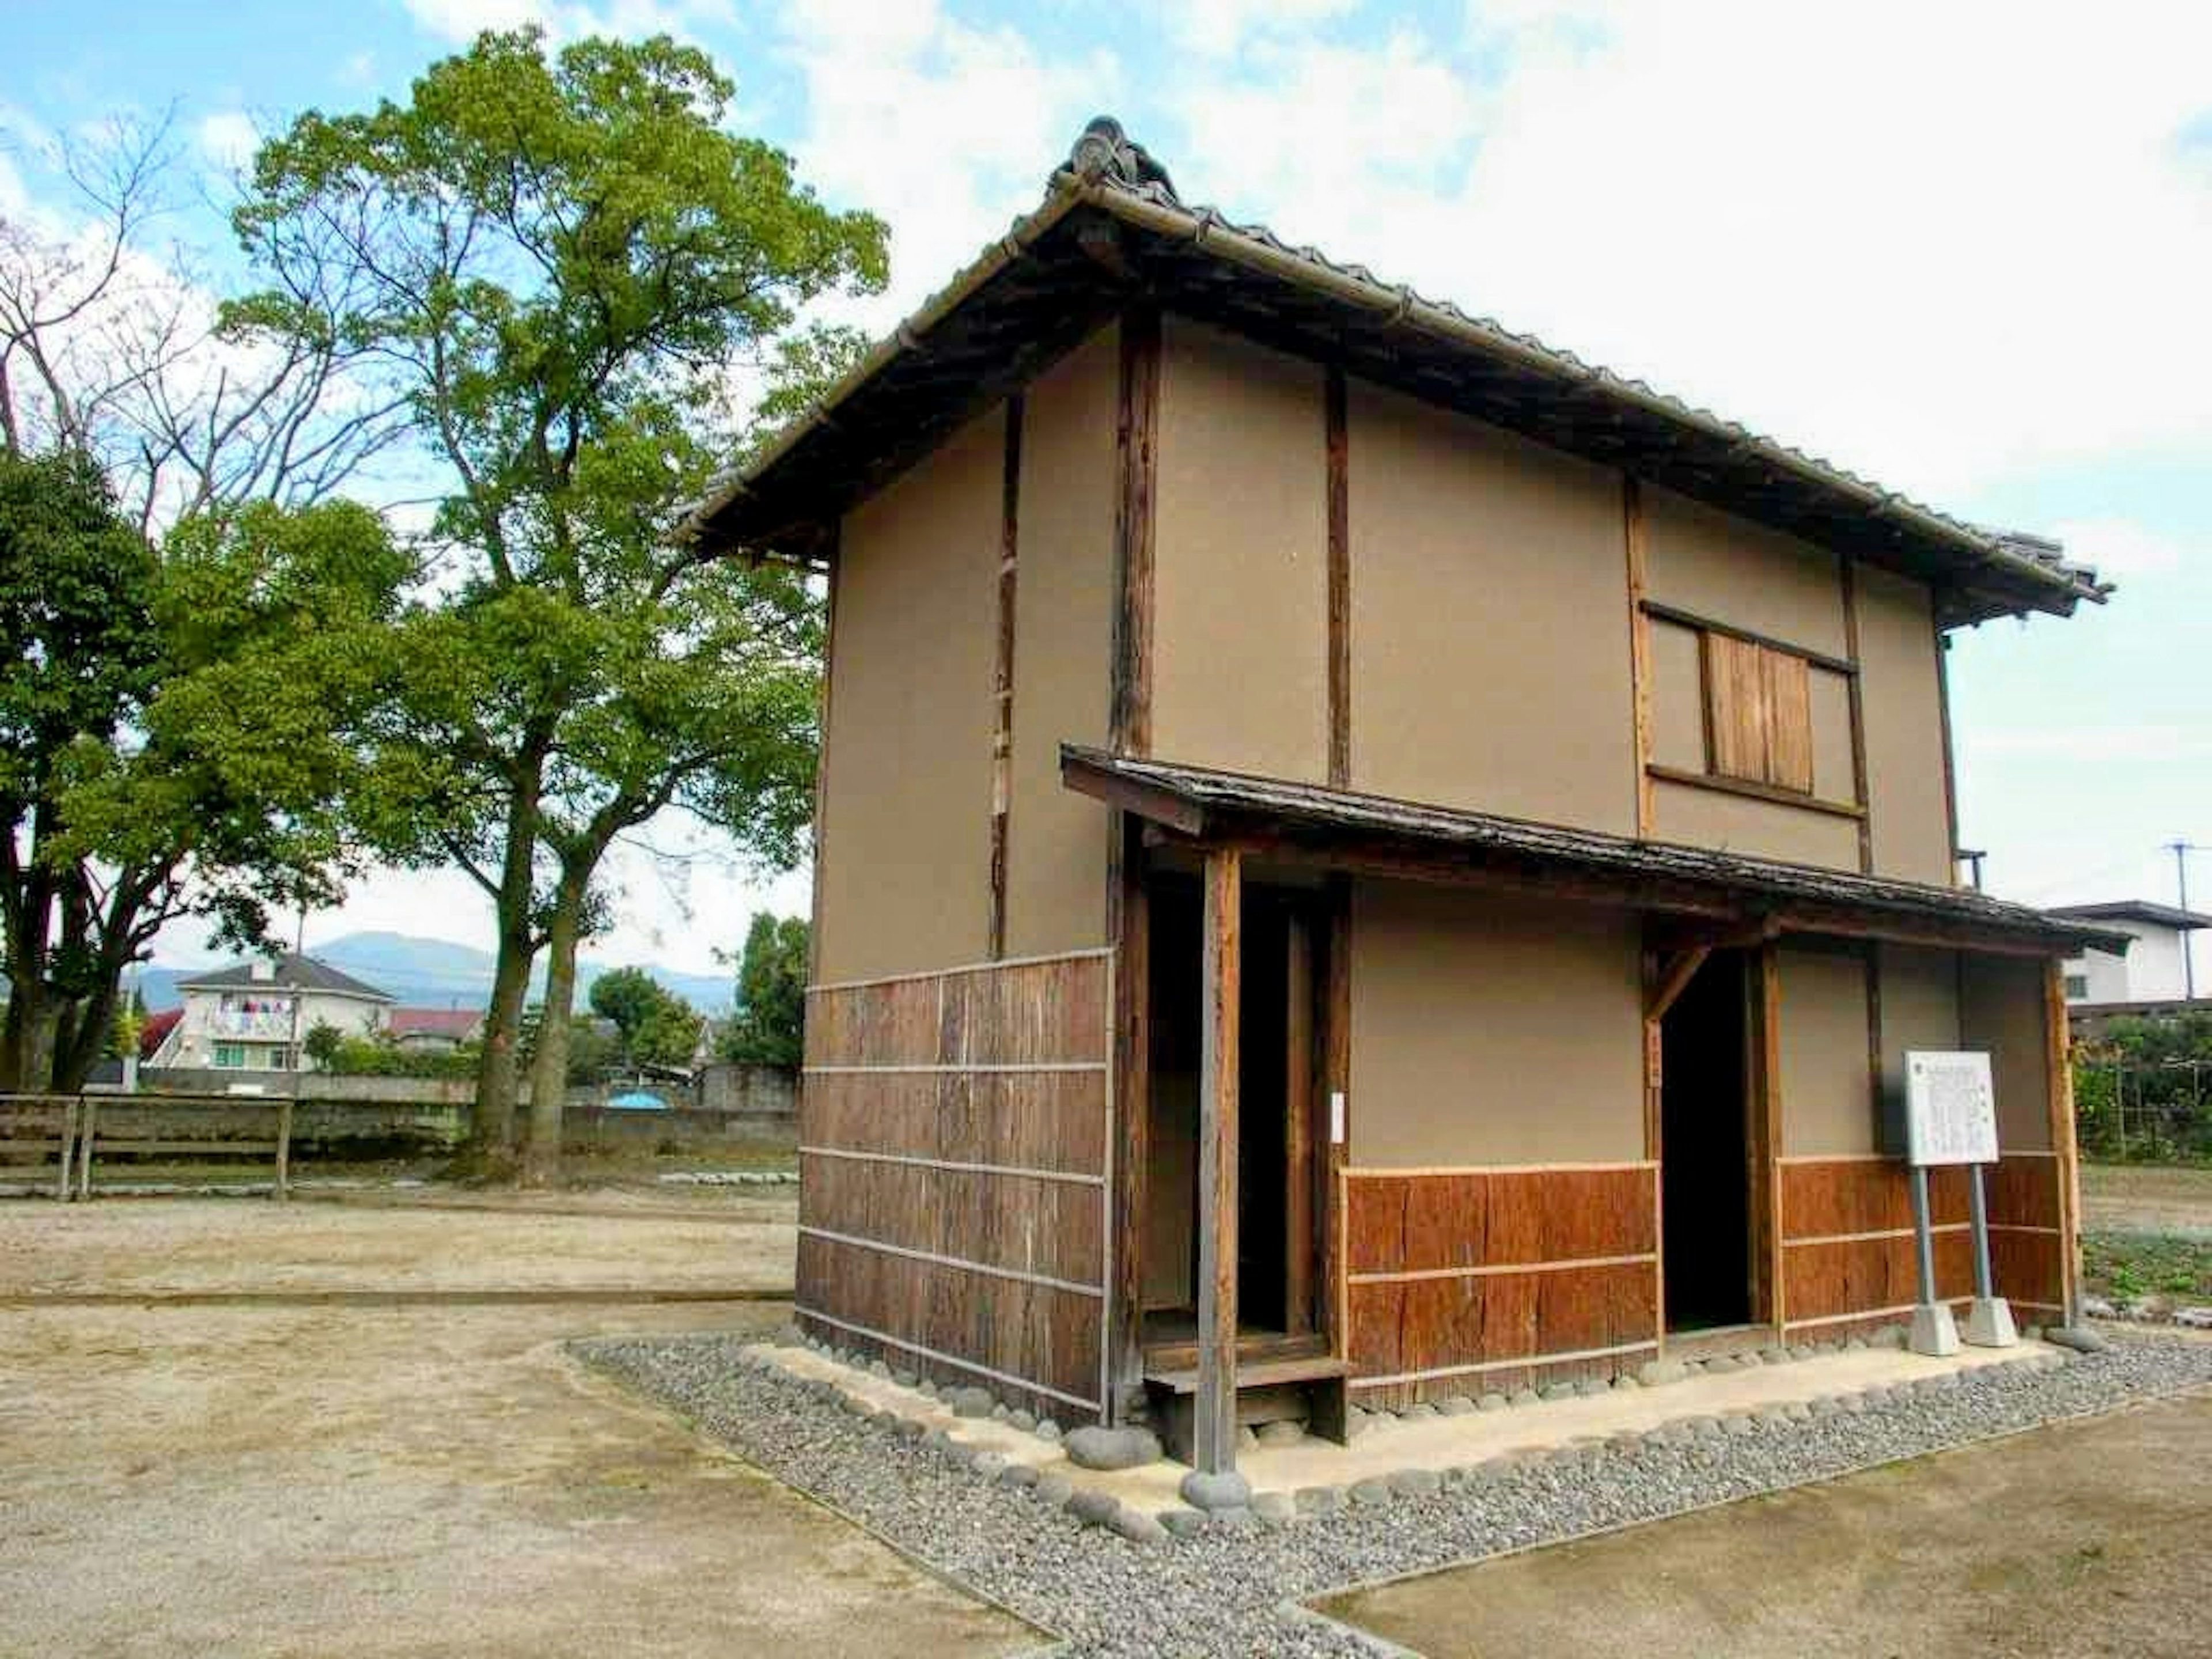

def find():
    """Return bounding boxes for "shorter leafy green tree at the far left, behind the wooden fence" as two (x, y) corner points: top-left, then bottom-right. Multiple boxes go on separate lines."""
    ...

(0, 449), (407, 1106)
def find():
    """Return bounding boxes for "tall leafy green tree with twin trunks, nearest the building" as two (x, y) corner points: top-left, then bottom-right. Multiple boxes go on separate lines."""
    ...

(230, 31), (885, 1179)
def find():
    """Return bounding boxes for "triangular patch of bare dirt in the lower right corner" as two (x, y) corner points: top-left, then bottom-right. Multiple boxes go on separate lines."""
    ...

(1325, 1393), (2212, 1659)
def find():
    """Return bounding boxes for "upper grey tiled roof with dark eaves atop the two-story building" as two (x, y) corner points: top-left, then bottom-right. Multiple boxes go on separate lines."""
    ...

(684, 118), (2110, 619)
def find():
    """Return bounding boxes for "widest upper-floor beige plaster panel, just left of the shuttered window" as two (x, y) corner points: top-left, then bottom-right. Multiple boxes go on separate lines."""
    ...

(1347, 382), (1635, 834)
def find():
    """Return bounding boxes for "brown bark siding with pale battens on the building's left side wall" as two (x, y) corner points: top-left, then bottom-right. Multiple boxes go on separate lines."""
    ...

(796, 951), (1115, 1418)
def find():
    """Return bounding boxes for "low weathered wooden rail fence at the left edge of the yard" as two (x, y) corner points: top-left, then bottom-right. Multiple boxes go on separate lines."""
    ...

(0, 1095), (292, 1199)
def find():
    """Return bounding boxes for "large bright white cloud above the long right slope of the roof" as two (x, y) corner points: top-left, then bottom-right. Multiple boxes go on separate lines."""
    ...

(1139, 0), (2212, 502)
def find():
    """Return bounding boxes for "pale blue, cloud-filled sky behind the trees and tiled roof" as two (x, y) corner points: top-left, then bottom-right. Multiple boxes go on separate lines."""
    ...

(0, 0), (2212, 982)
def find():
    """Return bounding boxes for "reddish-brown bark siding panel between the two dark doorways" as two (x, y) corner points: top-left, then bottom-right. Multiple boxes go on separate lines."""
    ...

(1340, 1161), (1659, 1404)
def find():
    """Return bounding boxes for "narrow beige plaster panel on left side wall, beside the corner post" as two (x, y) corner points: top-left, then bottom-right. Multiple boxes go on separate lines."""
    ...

(1006, 327), (1119, 956)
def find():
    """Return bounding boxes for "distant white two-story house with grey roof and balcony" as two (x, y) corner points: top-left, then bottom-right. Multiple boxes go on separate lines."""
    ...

(146, 951), (392, 1071)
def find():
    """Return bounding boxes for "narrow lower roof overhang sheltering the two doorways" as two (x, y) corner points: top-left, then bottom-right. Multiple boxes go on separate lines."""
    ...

(1059, 743), (2130, 958)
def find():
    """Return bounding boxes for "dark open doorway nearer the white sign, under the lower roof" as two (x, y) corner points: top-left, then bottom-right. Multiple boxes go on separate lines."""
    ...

(1659, 951), (1754, 1332)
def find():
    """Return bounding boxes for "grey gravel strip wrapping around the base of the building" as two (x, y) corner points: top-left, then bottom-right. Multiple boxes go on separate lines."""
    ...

(575, 1336), (2212, 1659)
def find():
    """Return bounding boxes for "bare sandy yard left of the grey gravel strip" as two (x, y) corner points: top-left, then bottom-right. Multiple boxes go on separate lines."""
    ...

(0, 1195), (1040, 1659)
